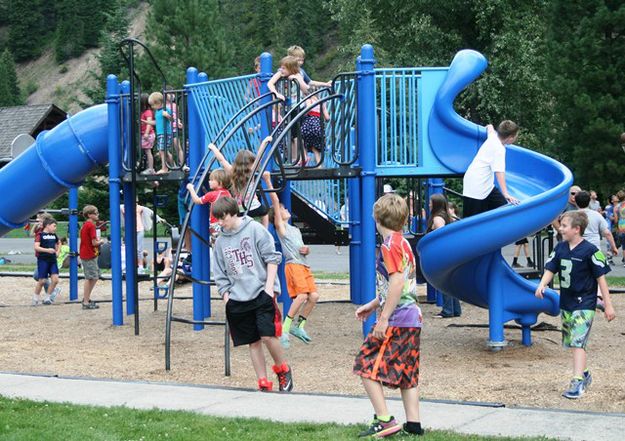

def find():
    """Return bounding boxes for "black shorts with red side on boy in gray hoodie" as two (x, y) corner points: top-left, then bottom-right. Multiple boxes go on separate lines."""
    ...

(226, 291), (282, 346)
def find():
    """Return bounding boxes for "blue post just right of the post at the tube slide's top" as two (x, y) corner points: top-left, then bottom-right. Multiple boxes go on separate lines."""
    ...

(120, 81), (137, 315)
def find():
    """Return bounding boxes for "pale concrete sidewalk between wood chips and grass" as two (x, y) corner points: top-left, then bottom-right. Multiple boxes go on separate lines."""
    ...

(0, 373), (625, 441)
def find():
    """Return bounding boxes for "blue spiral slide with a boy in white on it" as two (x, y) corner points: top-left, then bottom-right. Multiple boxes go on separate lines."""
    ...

(418, 50), (573, 347)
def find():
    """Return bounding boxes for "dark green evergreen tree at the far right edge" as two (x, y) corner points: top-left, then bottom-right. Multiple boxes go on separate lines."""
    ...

(548, 0), (625, 196)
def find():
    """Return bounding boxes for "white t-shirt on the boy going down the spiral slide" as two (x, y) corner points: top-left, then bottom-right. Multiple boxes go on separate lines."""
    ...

(462, 132), (506, 200)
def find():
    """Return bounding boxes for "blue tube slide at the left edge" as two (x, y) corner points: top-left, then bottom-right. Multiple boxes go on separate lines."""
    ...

(0, 104), (108, 237)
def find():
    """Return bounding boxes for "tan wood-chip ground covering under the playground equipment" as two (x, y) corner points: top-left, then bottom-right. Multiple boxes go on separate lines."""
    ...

(0, 277), (625, 412)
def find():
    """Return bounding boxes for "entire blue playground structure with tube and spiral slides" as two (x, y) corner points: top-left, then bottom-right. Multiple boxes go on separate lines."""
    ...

(0, 45), (572, 367)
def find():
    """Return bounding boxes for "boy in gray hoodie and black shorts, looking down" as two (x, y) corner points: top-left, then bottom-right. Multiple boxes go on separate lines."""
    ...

(212, 196), (293, 392)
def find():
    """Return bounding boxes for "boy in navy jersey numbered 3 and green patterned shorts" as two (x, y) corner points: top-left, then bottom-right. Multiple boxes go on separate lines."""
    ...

(535, 211), (615, 399)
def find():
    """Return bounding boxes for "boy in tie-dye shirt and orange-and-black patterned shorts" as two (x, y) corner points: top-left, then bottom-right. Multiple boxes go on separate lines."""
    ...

(354, 193), (423, 438)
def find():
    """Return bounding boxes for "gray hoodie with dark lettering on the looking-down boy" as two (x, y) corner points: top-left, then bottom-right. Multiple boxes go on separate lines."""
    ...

(213, 216), (282, 302)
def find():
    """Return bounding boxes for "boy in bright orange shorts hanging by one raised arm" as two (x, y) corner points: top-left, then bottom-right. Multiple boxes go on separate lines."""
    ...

(264, 174), (319, 348)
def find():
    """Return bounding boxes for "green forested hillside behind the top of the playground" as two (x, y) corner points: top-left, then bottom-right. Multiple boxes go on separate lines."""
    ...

(0, 0), (625, 195)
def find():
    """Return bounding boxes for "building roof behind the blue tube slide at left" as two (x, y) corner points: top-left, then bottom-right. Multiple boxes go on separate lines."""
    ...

(0, 104), (67, 163)
